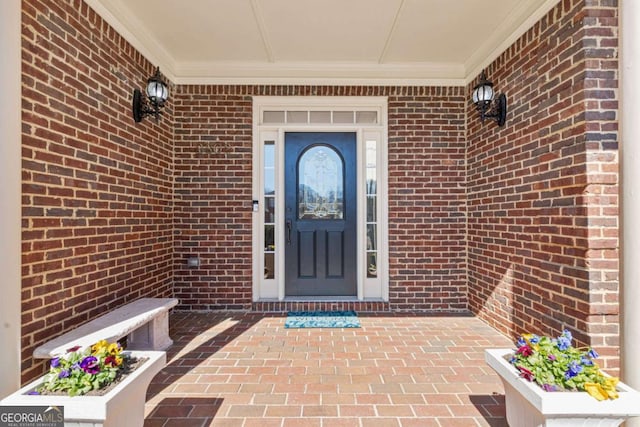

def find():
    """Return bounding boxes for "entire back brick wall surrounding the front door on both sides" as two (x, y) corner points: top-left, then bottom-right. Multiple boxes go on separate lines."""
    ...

(175, 86), (467, 310)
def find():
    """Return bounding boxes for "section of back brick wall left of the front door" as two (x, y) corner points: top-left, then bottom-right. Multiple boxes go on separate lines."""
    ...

(174, 86), (252, 310)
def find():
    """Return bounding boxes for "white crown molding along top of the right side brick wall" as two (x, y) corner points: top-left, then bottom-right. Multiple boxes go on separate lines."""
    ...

(464, 0), (560, 84)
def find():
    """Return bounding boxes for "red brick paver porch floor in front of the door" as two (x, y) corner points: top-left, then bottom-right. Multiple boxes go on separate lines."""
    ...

(145, 313), (511, 427)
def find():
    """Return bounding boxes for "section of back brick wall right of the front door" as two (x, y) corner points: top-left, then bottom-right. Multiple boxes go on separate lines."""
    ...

(389, 88), (467, 311)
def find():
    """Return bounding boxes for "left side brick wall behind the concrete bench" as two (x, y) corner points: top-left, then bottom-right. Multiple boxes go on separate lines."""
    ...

(22, 0), (173, 380)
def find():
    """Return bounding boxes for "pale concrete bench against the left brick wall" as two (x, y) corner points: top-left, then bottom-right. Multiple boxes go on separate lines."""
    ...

(33, 298), (178, 359)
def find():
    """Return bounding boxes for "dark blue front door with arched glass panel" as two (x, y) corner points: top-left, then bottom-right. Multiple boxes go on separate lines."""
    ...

(284, 132), (357, 296)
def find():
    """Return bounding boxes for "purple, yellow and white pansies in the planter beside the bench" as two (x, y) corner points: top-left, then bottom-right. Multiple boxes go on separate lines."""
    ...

(35, 340), (127, 396)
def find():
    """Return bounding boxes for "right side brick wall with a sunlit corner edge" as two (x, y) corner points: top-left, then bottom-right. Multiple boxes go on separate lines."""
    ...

(468, 0), (619, 368)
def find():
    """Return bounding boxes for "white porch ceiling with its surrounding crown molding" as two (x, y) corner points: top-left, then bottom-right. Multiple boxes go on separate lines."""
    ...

(86, 0), (559, 85)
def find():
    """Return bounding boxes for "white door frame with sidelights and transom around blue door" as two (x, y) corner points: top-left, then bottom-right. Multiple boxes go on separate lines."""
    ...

(252, 96), (389, 301)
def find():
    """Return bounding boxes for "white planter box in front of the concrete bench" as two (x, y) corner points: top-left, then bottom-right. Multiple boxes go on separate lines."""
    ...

(0, 351), (166, 427)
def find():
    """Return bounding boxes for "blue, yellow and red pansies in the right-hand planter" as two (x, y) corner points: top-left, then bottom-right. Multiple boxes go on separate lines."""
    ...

(510, 330), (618, 400)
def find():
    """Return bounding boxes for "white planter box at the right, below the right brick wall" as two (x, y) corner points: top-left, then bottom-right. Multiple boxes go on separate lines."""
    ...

(485, 349), (640, 427)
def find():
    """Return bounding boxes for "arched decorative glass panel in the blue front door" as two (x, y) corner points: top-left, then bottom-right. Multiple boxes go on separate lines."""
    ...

(298, 145), (344, 220)
